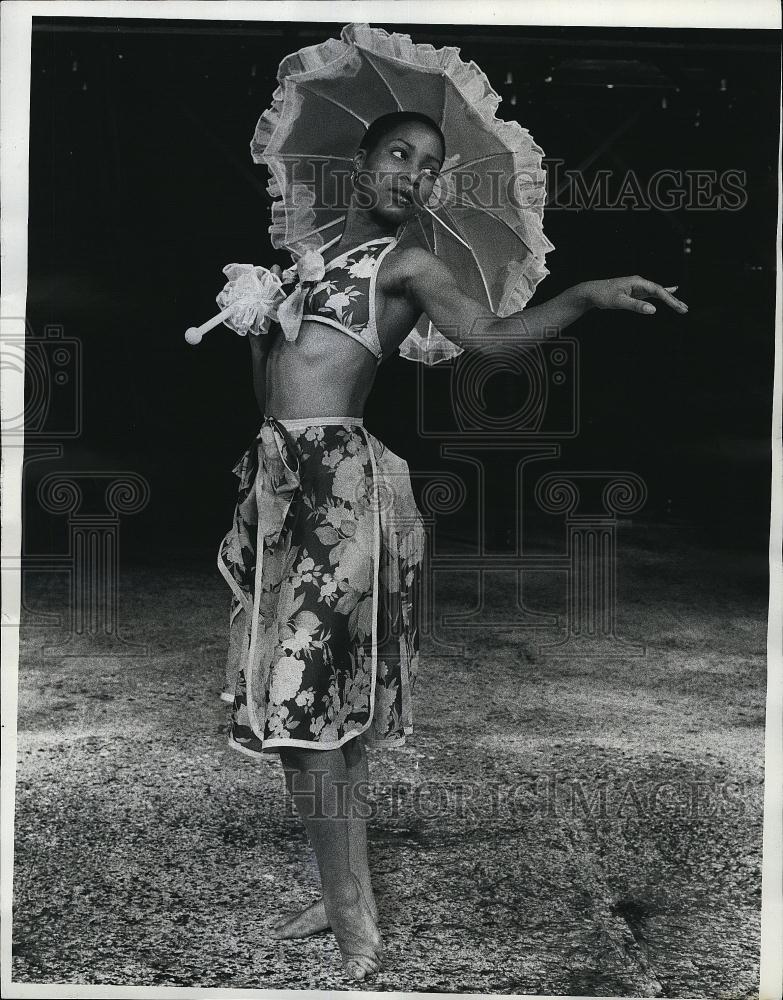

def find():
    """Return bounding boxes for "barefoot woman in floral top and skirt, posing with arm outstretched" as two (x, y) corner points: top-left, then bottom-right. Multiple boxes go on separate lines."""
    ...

(219, 112), (687, 980)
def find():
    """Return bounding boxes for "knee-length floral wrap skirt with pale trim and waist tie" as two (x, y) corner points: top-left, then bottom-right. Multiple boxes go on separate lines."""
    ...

(218, 417), (425, 756)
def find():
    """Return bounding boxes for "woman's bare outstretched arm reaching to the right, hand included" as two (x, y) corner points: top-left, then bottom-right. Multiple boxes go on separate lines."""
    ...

(401, 247), (688, 349)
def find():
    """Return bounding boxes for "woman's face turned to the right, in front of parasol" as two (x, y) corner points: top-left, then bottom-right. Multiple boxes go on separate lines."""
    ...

(356, 122), (443, 225)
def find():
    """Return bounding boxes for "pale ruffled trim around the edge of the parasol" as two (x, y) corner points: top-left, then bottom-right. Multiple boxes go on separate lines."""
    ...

(250, 24), (555, 365)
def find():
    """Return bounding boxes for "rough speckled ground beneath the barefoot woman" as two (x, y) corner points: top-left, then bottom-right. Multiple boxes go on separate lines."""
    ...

(13, 525), (766, 1000)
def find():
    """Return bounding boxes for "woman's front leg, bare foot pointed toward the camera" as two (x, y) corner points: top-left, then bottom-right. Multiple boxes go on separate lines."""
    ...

(280, 749), (381, 980)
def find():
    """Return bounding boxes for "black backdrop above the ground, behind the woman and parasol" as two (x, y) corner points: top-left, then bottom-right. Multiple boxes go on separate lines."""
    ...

(25, 18), (780, 561)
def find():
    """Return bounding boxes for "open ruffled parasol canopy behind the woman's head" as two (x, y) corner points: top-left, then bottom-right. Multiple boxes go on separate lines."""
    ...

(250, 24), (554, 365)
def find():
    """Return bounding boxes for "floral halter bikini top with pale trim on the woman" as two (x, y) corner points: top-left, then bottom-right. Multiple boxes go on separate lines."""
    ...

(302, 236), (397, 364)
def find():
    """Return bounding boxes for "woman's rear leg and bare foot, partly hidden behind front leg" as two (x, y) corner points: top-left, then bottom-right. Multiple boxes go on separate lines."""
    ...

(270, 737), (378, 940)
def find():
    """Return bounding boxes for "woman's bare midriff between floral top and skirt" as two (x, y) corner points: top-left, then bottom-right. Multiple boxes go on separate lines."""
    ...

(266, 320), (378, 420)
